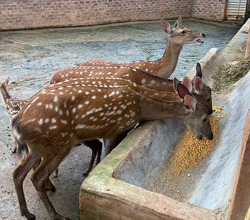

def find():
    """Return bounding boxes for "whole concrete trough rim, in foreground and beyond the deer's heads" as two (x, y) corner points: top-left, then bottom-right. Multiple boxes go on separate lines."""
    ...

(79, 19), (250, 220)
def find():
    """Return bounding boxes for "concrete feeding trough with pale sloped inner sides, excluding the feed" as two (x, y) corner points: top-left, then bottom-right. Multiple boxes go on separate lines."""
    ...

(80, 21), (250, 220)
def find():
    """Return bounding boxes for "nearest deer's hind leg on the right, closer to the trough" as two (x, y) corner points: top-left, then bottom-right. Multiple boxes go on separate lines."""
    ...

(31, 154), (69, 220)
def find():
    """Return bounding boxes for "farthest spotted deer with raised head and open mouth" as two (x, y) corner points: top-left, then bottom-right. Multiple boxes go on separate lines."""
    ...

(77, 17), (206, 78)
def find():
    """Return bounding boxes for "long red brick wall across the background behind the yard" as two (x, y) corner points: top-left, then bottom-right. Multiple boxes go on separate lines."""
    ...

(0, 0), (226, 29)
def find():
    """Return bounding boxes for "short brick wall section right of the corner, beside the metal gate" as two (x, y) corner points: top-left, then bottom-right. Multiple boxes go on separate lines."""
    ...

(192, 0), (226, 21)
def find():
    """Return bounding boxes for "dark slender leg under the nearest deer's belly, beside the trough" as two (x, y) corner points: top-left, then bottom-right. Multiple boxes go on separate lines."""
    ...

(83, 139), (102, 175)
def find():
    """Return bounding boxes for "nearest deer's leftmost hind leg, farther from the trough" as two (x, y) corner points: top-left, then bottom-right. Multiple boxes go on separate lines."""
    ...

(12, 152), (40, 220)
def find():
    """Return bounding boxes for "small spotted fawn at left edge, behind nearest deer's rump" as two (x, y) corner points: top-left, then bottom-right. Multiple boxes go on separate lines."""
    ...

(0, 77), (28, 153)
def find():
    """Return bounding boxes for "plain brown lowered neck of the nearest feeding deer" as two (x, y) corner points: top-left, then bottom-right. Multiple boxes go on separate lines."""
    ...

(139, 97), (188, 121)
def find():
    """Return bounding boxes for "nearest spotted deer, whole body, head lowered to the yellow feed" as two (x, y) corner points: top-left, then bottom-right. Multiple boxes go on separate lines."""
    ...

(12, 78), (213, 220)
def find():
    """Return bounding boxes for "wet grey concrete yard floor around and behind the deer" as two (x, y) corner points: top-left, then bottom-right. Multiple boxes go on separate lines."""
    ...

(0, 19), (238, 220)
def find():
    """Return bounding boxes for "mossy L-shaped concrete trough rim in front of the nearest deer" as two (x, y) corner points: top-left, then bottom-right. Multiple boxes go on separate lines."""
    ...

(80, 121), (218, 220)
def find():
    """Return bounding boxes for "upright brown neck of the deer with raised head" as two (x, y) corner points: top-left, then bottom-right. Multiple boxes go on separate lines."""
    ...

(156, 37), (182, 79)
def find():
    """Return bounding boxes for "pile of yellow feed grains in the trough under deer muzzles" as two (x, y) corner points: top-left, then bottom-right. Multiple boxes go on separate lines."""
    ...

(168, 107), (223, 177)
